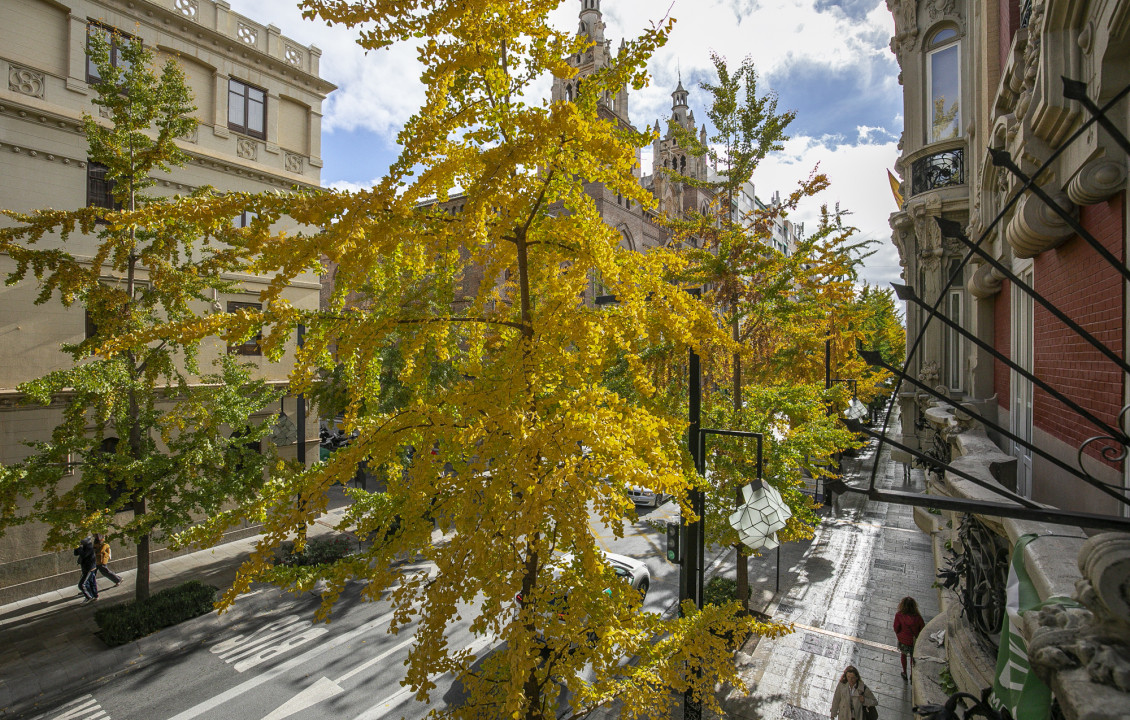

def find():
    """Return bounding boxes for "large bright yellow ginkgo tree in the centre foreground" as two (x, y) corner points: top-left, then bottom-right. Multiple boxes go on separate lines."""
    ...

(157, 0), (795, 719)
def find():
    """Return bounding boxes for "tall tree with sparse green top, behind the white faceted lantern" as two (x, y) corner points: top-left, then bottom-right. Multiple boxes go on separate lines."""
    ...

(664, 54), (866, 604)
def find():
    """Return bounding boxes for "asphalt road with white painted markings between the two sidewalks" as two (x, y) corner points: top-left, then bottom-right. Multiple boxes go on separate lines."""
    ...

(23, 503), (718, 720)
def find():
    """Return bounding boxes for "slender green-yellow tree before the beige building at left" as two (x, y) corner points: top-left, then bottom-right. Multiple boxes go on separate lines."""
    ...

(0, 34), (275, 599)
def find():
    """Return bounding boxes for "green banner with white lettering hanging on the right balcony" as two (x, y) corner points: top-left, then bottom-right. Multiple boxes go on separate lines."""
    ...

(989, 535), (1078, 720)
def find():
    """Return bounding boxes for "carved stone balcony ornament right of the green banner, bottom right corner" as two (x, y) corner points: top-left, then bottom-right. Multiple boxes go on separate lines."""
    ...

(1028, 532), (1130, 718)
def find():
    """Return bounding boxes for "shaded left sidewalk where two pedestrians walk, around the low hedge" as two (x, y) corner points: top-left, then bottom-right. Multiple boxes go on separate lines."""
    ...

(0, 508), (345, 718)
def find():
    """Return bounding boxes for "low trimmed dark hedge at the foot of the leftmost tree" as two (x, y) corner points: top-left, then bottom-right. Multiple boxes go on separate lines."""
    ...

(94, 580), (216, 648)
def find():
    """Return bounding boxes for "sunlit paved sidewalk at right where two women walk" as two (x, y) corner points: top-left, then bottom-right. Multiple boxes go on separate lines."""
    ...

(719, 424), (939, 720)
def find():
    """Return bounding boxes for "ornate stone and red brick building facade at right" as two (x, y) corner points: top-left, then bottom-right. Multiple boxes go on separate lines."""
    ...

(887, 0), (1130, 718)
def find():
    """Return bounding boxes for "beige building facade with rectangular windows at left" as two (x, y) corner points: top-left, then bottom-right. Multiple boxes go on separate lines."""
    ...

(0, 0), (333, 602)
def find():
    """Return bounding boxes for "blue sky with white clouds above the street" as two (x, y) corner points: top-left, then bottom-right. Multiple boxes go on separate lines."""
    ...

(224, 0), (903, 287)
